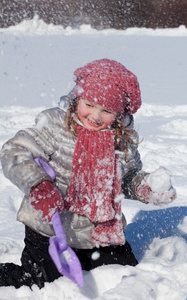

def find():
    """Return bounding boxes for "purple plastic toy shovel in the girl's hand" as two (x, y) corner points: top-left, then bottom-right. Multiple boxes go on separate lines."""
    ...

(35, 158), (84, 286)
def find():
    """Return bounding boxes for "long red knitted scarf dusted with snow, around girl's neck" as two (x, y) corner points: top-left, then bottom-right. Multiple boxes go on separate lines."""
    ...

(64, 127), (125, 246)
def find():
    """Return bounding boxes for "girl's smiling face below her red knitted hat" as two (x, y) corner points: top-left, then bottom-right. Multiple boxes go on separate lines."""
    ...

(77, 99), (116, 131)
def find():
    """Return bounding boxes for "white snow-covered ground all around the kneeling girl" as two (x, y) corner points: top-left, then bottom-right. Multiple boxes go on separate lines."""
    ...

(0, 18), (187, 300)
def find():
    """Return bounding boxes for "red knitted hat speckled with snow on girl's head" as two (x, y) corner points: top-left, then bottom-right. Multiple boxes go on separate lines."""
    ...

(74, 58), (141, 114)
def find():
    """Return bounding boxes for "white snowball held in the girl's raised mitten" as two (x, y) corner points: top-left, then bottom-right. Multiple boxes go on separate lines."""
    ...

(147, 167), (171, 193)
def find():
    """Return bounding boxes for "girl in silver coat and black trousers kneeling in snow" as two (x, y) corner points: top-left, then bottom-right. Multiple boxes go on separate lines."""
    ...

(0, 59), (176, 288)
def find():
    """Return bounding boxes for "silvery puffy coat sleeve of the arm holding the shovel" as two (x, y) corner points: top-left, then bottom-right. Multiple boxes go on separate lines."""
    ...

(0, 110), (54, 196)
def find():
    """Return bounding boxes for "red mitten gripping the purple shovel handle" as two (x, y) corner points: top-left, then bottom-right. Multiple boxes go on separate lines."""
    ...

(30, 181), (64, 222)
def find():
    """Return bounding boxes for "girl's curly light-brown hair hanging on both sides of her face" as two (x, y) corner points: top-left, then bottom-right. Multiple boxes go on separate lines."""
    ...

(65, 97), (136, 161)
